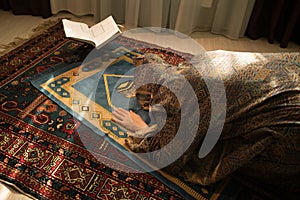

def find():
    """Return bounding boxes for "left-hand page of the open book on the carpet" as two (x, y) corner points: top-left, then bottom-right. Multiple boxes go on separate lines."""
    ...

(62, 19), (94, 42)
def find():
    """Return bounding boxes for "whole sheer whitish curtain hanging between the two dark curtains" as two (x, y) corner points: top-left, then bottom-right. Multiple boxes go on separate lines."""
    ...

(51, 0), (255, 38)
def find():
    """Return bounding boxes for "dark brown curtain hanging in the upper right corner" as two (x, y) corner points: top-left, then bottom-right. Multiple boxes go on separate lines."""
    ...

(246, 0), (300, 48)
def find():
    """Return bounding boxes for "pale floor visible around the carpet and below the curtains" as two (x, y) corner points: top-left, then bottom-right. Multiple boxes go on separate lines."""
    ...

(0, 10), (300, 200)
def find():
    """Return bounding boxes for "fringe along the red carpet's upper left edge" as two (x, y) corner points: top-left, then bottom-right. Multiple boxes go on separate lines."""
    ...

(0, 18), (63, 56)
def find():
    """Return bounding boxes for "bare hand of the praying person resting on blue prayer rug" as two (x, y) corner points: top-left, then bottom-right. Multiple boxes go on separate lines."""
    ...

(112, 108), (148, 132)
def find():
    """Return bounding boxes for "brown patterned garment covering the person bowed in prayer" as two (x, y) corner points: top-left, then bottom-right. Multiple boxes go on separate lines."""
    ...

(127, 51), (300, 195)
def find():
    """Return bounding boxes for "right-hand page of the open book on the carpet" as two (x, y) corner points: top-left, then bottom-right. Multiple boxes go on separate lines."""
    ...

(90, 16), (121, 47)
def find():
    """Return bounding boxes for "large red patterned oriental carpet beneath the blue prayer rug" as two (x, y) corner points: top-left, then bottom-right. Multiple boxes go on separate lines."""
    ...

(0, 19), (272, 199)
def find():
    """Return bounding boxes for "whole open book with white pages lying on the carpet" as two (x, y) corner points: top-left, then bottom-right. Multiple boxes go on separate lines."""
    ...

(62, 16), (121, 47)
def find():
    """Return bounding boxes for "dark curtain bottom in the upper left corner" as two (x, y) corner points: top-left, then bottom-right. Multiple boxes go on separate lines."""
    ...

(0, 0), (52, 18)
